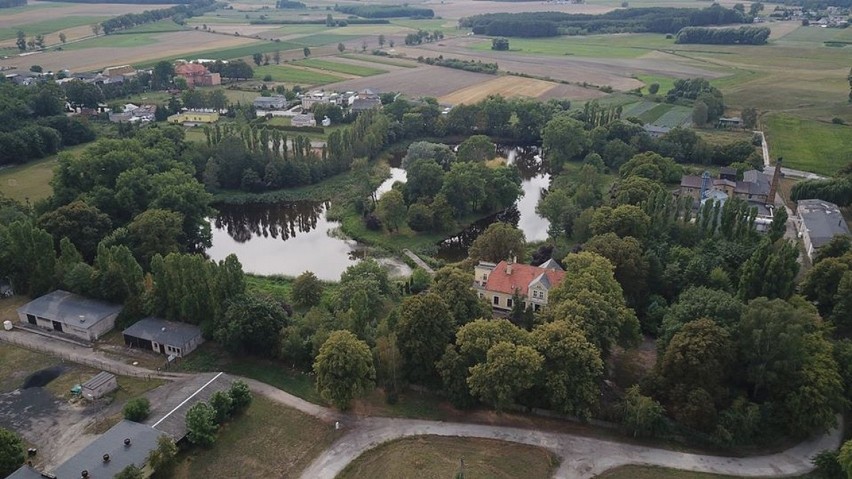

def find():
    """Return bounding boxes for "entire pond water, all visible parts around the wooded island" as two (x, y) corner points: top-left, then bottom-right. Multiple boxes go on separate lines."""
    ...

(207, 147), (550, 281)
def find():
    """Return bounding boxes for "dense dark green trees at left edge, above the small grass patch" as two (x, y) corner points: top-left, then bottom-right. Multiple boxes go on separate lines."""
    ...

(0, 79), (95, 165)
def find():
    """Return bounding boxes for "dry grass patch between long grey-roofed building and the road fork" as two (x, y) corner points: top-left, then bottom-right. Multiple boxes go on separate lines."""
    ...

(171, 395), (339, 479)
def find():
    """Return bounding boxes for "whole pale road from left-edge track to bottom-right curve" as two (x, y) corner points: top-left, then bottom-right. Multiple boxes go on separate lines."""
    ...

(0, 331), (842, 479)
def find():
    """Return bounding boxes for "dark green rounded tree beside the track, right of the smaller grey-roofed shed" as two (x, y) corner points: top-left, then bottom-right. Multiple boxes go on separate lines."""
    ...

(214, 295), (287, 357)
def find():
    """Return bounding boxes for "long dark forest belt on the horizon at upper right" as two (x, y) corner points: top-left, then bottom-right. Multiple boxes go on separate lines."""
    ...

(459, 5), (751, 37)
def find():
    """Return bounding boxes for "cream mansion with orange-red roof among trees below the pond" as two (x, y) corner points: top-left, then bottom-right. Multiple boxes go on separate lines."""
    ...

(473, 259), (565, 311)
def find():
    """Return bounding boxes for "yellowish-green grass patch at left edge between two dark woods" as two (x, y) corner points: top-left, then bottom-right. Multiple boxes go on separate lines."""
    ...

(0, 145), (88, 202)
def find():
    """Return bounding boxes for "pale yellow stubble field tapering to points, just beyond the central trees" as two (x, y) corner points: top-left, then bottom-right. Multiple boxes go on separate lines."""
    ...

(438, 76), (602, 105)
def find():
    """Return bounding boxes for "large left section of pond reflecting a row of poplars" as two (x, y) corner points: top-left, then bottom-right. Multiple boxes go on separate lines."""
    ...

(207, 201), (411, 281)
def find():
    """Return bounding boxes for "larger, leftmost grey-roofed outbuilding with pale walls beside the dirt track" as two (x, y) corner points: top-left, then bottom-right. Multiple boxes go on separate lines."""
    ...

(18, 290), (122, 341)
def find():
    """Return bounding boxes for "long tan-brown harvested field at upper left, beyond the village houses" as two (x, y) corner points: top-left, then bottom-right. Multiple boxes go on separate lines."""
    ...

(0, 30), (257, 72)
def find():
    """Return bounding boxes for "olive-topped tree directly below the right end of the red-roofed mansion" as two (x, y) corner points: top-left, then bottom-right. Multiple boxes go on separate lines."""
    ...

(531, 321), (604, 419)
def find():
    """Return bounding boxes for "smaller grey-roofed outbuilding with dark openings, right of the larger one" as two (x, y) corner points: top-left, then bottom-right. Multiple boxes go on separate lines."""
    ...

(123, 317), (204, 357)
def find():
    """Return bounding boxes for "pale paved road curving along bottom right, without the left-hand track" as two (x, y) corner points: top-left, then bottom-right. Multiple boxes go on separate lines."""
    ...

(302, 417), (842, 479)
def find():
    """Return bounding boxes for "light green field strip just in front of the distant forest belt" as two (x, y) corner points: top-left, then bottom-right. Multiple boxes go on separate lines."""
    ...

(473, 33), (674, 58)
